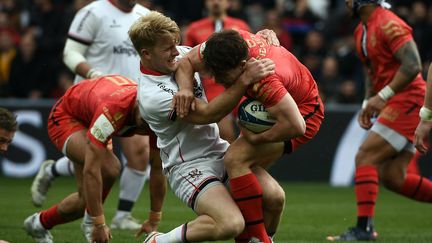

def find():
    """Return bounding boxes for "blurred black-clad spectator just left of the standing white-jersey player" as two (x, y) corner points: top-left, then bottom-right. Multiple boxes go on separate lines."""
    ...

(9, 32), (52, 99)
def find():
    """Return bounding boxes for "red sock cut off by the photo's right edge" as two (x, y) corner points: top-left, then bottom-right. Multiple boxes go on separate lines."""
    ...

(399, 174), (432, 202)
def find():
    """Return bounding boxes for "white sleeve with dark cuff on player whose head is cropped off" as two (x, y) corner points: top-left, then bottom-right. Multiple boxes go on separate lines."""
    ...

(68, 4), (101, 45)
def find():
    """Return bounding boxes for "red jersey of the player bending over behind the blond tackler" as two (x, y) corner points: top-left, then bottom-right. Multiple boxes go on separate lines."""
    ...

(60, 75), (137, 147)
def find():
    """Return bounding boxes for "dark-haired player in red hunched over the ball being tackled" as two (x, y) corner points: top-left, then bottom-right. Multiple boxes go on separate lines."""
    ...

(176, 30), (324, 242)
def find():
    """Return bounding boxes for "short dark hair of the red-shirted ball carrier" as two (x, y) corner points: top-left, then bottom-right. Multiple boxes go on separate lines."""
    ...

(202, 30), (248, 78)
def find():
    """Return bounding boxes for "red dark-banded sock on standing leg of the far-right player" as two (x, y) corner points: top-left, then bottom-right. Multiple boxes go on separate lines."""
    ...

(355, 165), (378, 217)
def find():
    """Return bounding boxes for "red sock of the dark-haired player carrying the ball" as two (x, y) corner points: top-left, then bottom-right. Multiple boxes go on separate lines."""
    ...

(230, 173), (270, 243)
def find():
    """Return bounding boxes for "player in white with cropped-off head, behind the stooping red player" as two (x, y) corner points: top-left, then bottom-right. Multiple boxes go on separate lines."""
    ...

(31, 0), (162, 236)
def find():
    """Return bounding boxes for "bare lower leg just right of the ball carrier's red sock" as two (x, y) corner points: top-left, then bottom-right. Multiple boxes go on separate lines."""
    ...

(252, 166), (285, 240)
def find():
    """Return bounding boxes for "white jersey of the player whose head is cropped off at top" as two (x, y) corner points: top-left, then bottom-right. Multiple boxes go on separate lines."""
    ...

(68, 0), (149, 83)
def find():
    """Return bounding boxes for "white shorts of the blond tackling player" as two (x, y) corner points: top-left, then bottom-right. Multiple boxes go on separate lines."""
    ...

(166, 158), (228, 210)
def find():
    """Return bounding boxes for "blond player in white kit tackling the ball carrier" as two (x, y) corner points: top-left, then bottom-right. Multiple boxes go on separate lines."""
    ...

(129, 11), (285, 243)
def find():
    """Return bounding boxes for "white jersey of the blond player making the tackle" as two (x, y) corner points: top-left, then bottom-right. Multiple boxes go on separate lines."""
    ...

(138, 46), (229, 169)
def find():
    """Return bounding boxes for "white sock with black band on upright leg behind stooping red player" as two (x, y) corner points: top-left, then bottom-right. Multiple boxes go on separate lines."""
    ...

(114, 166), (147, 218)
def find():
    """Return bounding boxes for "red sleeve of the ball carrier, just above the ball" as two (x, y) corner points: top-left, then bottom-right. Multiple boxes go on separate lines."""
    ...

(248, 75), (288, 108)
